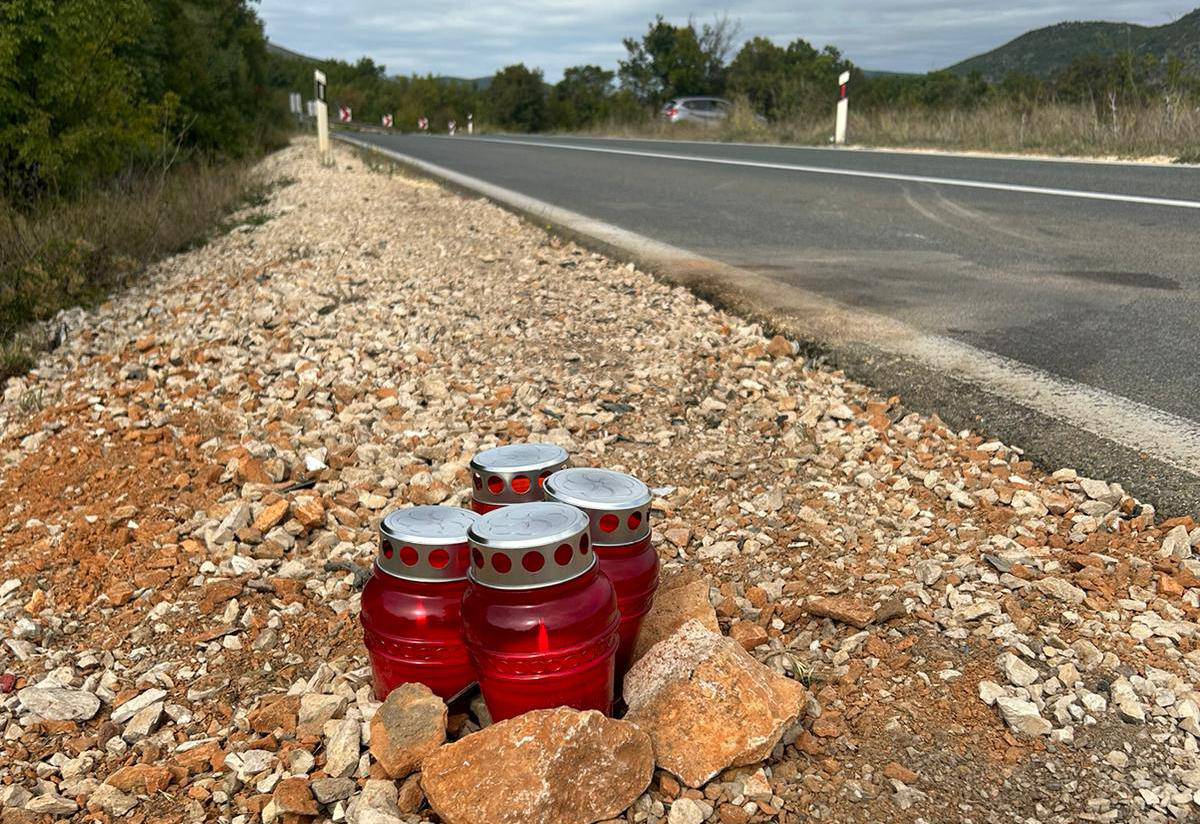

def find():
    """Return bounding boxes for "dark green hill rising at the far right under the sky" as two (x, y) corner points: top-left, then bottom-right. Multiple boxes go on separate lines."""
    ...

(949, 8), (1200, 80)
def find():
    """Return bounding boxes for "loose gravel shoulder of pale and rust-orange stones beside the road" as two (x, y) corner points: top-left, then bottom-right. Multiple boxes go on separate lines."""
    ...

(0, 140), (1200, 824)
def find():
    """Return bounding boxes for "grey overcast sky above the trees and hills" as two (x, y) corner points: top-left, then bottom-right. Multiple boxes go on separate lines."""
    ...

(259, 0), (1195, 82)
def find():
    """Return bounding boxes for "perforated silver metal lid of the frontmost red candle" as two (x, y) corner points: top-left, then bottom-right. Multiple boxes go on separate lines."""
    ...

(467, 501), (596, 589)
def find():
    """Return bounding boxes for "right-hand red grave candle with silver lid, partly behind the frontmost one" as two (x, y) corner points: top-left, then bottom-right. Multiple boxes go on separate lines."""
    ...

(546, 467), (659, 686)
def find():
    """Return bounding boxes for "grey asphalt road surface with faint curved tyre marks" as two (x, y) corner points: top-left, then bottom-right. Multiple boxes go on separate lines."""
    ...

(340, 134), (1200, 510)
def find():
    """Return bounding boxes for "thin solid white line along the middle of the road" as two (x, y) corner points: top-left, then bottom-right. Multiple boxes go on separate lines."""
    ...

(472, 137), (1200, 209)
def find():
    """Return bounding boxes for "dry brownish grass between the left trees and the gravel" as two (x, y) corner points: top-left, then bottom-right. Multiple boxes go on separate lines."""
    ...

(0, 162), (283, 381)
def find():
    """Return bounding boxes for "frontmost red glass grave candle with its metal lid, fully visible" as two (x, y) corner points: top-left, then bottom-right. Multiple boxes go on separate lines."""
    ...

(462, 503), (619, 721)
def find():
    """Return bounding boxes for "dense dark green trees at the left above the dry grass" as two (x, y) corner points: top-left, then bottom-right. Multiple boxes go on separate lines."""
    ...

(0, 0), (274, 204)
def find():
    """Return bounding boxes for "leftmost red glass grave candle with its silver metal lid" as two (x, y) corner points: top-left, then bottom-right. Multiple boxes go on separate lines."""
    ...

(359, 506), (479, 700)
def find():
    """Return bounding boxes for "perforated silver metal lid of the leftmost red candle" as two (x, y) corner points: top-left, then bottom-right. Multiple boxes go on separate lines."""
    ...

(376, 506), (479, 583)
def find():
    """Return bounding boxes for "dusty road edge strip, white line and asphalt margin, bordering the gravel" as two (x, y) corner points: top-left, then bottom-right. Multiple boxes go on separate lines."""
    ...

(335, 136), (1200, 517)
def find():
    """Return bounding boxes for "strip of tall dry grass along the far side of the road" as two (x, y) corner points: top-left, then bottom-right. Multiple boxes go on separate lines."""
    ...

(576, 101), (1200, 162)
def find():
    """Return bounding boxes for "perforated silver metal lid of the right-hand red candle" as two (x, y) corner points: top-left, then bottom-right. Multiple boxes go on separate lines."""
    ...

(546, 467), (652, 547)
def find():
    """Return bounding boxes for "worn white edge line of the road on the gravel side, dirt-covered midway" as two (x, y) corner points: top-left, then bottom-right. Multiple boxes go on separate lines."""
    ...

(338, 136), (1200, 475)
